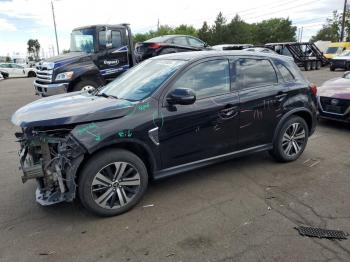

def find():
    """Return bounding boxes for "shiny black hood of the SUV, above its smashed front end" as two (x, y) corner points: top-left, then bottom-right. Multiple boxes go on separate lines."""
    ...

(11, 92), (134, 128)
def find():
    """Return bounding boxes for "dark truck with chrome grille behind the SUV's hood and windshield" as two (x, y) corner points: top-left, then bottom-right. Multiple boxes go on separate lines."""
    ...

(34, 24), (135, 96)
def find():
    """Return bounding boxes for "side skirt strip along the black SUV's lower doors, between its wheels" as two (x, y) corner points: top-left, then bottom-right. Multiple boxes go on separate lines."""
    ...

(153, 144), (273, 180)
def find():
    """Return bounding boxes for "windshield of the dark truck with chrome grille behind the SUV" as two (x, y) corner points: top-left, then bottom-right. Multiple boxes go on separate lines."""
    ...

(70, 28), (95, 53)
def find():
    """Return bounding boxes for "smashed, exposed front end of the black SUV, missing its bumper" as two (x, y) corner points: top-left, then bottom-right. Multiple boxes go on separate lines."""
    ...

(16, 128), (85, 206)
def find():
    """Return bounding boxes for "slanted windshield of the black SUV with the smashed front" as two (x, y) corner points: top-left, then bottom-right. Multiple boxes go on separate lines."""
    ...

(99, 59), (185, 101)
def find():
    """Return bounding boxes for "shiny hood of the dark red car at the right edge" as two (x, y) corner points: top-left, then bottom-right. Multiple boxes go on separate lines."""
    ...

(317, 77), (350, 100)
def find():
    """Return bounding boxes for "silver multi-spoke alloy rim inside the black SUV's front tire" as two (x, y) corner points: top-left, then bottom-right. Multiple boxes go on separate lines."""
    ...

(91, 162), (141, 209)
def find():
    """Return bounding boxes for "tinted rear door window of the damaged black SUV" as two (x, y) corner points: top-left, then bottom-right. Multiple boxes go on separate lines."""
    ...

(237, 58), (278, 88)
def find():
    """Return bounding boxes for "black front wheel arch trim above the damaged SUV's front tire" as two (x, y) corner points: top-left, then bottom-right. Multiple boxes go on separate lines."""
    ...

(76, 143), (155, 182)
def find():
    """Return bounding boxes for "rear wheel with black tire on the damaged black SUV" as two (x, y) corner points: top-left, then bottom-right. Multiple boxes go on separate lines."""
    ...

(270, 116), (309, 162)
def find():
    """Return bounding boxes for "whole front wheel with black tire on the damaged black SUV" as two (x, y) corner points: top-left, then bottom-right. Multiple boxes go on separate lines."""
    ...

(78, 149), (148, 216)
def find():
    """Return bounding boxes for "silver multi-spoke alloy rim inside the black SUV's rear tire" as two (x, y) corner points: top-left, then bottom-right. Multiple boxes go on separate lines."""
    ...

(282, 123), (306, 157)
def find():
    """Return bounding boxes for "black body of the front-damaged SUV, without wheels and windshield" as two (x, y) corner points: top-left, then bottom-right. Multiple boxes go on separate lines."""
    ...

(12, 51), (317, 207)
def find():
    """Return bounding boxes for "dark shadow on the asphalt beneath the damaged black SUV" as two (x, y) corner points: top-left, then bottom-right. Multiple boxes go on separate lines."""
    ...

(38, 152), (278, 222)
